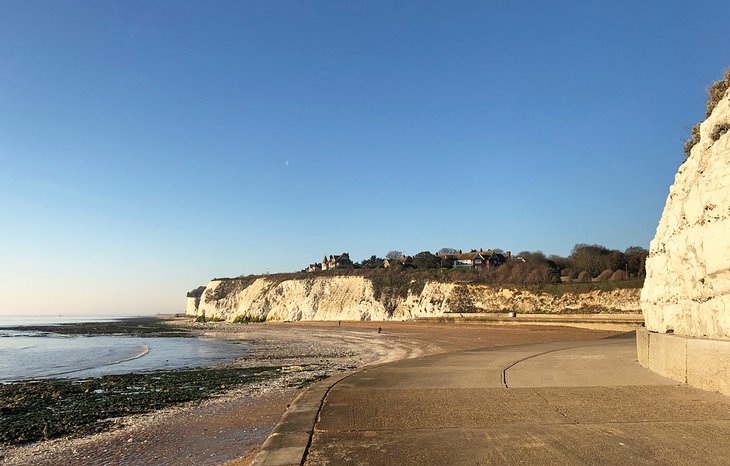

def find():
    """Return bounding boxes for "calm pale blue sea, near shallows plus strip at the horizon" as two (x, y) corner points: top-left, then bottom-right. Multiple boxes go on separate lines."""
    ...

(0, 315), (247, 383)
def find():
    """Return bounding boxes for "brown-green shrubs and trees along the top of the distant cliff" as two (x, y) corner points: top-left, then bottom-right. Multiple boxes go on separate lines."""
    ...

(188, 244), (648, 299)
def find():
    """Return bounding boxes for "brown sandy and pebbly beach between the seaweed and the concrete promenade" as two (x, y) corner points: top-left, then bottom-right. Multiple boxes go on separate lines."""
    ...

(0, 319), (616, 465)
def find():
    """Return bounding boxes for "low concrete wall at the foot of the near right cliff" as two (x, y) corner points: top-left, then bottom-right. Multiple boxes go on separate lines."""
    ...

(636, 328), (730, 395)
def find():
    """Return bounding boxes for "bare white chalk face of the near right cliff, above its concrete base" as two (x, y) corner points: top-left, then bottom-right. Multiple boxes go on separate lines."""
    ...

(641, 83), (730, 339)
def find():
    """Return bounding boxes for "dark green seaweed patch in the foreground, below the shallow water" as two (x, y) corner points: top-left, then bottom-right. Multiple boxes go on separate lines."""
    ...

(0, 366), (281, 446)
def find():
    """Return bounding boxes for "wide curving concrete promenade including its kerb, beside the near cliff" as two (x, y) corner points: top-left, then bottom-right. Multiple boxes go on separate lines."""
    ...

(254, 335), (730, 465)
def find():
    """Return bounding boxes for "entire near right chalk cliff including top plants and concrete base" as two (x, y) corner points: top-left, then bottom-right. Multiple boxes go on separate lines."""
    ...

(636, 71), (730, 395)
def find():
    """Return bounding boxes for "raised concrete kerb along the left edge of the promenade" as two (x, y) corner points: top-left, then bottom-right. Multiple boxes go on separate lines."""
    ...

(251, 373), (351, 466)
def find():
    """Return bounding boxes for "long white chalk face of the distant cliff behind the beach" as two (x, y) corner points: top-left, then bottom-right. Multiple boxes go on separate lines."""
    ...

(186, 276), (639, 321)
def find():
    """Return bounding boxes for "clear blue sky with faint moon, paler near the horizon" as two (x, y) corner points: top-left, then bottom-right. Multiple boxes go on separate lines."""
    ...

(0, 0), (730, 314)
